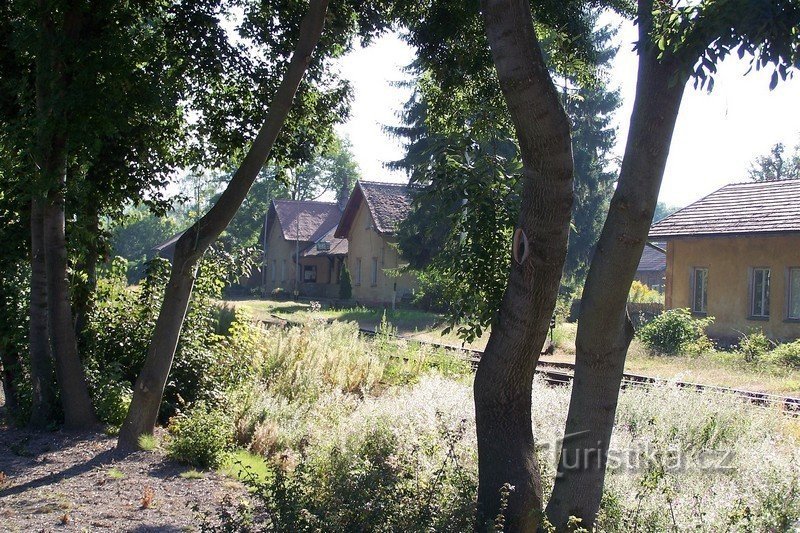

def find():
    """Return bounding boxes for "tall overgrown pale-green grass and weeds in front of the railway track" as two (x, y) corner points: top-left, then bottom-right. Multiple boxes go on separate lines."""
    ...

(194, 323), (800, 532)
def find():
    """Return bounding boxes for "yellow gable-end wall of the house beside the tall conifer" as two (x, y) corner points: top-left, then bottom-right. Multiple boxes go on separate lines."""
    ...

(347, 201), (419, 305)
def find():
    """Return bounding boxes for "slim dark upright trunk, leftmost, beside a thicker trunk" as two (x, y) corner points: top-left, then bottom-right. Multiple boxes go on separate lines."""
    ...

(29, 199), (53, 428)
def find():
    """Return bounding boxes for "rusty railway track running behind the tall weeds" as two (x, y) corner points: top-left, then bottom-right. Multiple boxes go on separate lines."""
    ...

(262, 315), (800, 417)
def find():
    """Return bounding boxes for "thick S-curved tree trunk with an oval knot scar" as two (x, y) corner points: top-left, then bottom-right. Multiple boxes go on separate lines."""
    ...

(474, 0), (573, 531)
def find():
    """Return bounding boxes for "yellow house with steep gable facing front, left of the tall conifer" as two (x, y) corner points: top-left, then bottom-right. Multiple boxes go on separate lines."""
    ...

(334, 181), (418, 305)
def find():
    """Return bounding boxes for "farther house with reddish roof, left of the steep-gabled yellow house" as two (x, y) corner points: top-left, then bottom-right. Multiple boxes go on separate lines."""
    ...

(261, 200), (347, 298)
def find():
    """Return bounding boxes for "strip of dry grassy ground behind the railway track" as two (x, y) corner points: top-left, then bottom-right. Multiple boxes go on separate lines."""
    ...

(225, 299), (800, 396)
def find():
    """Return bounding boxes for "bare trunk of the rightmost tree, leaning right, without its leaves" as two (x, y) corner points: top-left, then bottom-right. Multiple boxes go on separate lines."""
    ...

(547, 0), (688, 530)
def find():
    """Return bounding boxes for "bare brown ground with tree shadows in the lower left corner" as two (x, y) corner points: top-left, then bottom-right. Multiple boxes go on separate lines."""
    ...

(0, 425), (245, 532)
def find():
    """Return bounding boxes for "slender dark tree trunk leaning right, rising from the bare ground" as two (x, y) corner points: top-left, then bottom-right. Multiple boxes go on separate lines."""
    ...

(117, 0), (328, 450)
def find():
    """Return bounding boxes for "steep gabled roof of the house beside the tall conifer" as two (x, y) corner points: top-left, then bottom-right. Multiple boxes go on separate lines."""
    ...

(335, 180), (411, 239)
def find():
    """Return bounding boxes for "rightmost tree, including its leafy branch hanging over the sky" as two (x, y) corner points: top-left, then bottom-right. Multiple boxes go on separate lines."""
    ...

(546, 0), (800, 529)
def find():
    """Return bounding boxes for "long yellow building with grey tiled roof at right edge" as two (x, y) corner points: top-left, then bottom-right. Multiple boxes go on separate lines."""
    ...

(650, 180), (800, 342)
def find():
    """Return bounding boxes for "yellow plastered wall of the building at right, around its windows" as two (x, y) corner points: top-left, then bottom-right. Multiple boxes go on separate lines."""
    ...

(666, 235), (800, 341)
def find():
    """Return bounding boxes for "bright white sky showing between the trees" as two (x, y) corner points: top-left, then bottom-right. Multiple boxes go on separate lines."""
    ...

(338, 20), (800, 207)
